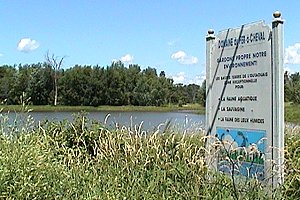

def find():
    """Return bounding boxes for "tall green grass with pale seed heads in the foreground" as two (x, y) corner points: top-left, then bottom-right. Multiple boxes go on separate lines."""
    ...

(0, 113), (300, 199)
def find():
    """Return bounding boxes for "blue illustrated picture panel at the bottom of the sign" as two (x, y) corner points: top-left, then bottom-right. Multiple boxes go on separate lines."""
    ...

(216, 127), (266, 180)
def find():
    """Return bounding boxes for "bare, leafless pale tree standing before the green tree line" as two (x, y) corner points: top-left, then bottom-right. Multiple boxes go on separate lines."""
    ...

(45, 51), (65, 106)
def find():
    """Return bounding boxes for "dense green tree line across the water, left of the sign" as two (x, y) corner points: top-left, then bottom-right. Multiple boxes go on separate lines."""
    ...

(0, 61), (205, 106)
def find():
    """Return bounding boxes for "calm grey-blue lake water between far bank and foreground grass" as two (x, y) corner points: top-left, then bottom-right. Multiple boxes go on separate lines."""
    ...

(2, 111), (205, 133)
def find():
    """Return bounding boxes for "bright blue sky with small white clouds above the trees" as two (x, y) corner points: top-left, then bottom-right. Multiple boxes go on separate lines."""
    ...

(0, 0), (300, 84)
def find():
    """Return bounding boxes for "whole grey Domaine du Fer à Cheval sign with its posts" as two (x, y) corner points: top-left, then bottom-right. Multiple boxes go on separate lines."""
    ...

(206, 12), (284, 186)
